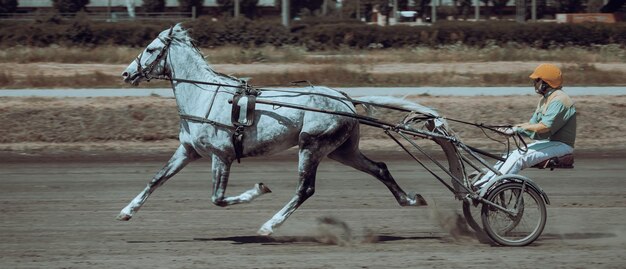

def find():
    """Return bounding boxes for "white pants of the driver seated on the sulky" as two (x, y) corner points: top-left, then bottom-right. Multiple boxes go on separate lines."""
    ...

(474, 140), (574, 186)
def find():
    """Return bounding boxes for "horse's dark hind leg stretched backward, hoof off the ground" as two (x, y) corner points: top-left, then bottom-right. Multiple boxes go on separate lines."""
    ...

(328, 135), (427, 206)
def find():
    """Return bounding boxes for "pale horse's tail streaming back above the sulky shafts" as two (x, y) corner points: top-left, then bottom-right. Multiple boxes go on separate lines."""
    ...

(352, 96), (450, 130)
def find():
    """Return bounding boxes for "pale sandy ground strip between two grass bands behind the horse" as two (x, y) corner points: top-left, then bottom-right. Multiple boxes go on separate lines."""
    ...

(0, 61), (626, 77)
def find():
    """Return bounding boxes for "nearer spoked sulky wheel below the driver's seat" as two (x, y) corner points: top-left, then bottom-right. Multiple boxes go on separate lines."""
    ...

(481, 182), (547, 246)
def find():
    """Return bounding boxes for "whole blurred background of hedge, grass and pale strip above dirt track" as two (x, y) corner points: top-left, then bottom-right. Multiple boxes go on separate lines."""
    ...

(0, 0), (626, 153)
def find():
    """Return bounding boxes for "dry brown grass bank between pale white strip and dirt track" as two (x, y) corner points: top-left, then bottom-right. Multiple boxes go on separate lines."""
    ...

(0, 96), (626, 150)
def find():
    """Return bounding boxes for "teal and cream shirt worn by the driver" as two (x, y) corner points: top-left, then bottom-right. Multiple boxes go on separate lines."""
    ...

(523, 89), (576, 147)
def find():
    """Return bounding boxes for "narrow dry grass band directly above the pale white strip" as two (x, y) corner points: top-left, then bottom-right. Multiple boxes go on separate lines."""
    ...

(0, 64), (626, 88)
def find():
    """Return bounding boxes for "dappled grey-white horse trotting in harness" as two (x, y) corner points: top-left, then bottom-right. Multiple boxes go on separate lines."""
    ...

(118, 24), (458, 235)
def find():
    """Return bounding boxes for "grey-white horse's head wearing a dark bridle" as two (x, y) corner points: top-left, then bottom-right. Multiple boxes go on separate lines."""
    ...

(122, 23), (189, 85)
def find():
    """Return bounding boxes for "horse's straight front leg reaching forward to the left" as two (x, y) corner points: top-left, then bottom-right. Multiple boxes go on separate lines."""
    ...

(117, 145), (200, 220)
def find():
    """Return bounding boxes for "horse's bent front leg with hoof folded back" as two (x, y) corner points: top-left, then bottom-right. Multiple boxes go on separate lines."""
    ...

(211, 155), (272, 206)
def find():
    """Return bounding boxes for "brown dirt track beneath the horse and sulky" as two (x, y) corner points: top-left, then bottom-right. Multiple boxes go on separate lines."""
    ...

(0, 156), (626, 268)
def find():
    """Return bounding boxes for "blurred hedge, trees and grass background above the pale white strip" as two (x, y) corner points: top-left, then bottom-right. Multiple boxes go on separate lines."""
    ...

(0, 0), (626, 88)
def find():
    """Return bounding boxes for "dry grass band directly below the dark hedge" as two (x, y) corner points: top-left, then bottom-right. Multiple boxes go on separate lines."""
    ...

(0, 45), (626, 64)
